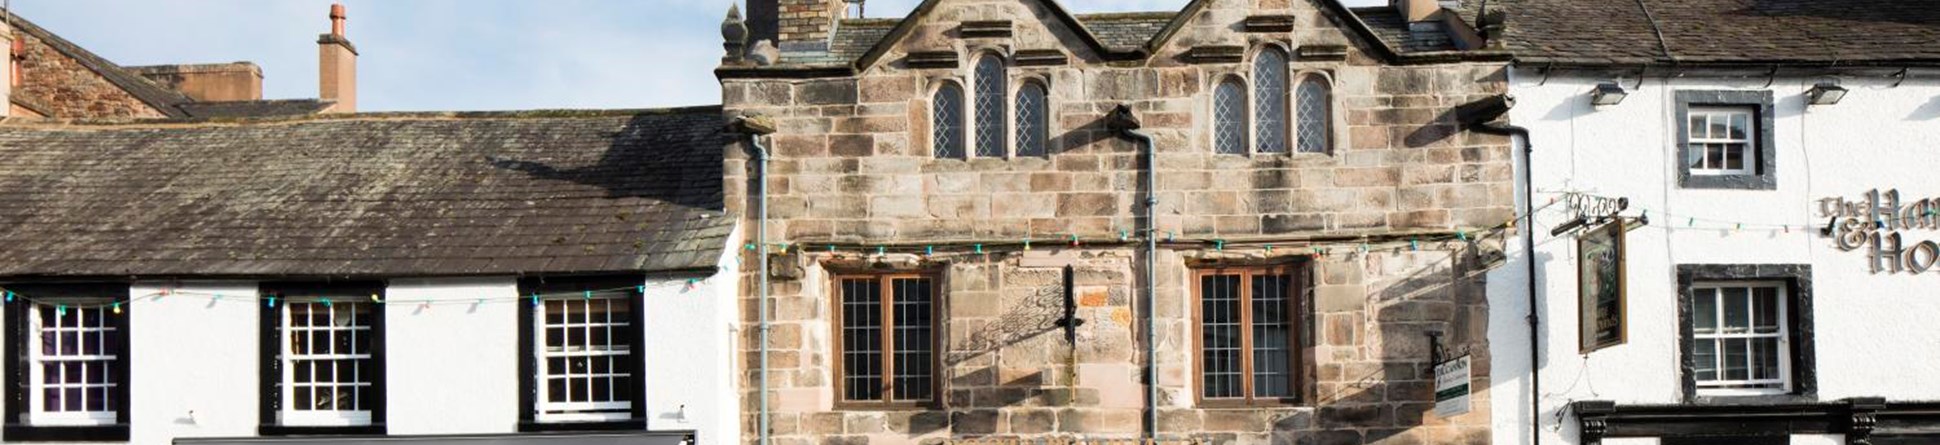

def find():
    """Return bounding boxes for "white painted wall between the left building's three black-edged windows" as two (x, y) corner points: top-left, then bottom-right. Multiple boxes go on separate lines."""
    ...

(6, 260), (741, 445)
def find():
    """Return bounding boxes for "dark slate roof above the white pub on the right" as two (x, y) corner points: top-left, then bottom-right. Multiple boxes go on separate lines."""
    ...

(1488, 0), (1940, 64)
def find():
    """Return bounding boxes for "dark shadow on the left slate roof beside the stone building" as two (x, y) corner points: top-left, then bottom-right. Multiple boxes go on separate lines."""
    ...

(485, 111), (731, 210)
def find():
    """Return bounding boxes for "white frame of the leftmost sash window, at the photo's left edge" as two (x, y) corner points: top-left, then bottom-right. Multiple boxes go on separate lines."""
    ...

(23, 301), (126, 426)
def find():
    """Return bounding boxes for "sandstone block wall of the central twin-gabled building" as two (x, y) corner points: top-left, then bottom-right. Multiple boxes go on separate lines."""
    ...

(722, 0), (1513, 443)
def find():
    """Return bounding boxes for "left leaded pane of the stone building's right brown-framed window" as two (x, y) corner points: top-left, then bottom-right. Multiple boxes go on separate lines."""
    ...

(1199, 274), (1245, 398)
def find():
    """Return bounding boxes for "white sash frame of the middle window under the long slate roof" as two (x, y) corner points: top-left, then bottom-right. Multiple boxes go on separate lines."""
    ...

(277, 299), (382, 426)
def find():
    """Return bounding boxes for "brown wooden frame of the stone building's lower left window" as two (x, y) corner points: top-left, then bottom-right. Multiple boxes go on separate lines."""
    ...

(828, 272), (947, 410)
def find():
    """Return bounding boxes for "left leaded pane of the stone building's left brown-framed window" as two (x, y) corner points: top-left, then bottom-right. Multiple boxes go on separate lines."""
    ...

(842, 278), (883, 400)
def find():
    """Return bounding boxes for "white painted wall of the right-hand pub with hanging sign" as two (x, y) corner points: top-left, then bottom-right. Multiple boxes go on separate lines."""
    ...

(1488, 70), (1940, 443)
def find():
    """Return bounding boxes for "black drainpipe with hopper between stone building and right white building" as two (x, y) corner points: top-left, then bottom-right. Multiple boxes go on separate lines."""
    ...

(1455, 95), (1542, 445)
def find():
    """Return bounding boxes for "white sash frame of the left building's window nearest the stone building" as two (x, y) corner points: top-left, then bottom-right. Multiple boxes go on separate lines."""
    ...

(532, 291), (642, 424)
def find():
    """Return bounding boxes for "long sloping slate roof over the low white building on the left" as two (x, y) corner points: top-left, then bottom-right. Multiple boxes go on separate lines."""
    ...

(0, 107), (733, 276)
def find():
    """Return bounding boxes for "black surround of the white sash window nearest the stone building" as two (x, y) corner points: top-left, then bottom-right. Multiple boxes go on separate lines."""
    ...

(516, 276), (646, 433)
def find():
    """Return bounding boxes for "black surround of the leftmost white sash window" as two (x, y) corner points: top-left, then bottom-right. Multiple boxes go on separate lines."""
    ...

(0, 284), (134, 441)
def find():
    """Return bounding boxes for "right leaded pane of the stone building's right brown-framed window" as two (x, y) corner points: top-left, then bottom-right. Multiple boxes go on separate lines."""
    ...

(1253, 276), (1294, 398)
